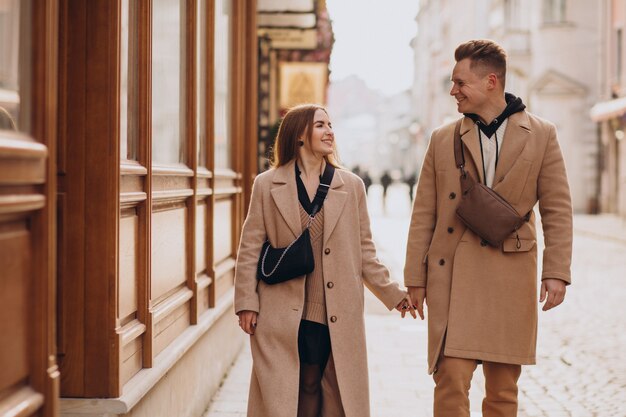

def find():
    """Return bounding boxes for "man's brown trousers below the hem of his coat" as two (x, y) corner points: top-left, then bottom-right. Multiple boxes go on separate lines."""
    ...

(433, 355), (522, 417)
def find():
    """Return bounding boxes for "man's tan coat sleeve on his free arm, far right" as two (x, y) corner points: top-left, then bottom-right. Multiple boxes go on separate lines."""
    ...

(537, 125), (573, 284)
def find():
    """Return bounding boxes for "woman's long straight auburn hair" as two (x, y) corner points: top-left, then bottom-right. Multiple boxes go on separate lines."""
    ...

(270, 104), (341, 168)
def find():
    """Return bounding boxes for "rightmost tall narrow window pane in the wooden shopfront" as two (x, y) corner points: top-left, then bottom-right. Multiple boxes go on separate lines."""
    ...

(214, 0), (232, 168)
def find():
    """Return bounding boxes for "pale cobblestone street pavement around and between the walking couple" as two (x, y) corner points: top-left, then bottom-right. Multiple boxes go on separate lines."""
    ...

(203, 186), (626, 417)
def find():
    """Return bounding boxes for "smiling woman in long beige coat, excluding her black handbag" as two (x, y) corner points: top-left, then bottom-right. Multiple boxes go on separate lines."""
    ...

(235, 104), (414, 417)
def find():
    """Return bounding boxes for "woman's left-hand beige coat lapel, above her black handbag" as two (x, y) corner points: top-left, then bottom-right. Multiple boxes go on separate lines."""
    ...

(271, 162), (302, 238)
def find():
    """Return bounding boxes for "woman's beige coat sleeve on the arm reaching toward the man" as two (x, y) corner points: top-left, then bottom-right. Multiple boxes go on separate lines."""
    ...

(357, 181), (406, 310)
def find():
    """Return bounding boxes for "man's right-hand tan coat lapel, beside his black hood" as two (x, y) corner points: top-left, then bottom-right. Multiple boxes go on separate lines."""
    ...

(493, 112), (530, 187)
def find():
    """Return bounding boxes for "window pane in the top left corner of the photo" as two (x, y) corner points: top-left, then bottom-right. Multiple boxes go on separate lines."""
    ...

(0, 0), (32, 132)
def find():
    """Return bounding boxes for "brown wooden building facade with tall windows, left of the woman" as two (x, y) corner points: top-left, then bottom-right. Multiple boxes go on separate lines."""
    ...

(0, 0), (257, 417)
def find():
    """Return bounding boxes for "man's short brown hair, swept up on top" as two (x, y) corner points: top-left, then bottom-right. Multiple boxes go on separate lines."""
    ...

(454, 39), (506, 87)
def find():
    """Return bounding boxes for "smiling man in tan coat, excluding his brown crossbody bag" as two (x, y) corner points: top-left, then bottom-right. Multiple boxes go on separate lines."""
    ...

(404, 40), (572, 417)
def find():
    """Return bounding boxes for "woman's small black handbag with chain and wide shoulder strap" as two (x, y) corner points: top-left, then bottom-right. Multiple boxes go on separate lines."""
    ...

(256, 163), (335, 285)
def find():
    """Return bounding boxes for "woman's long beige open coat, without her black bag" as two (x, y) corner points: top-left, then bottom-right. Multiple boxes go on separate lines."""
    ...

(235, 162), (405, 417)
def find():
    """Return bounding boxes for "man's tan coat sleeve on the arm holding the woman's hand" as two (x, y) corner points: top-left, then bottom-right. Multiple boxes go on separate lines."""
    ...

(404, 131), (437, 287)
